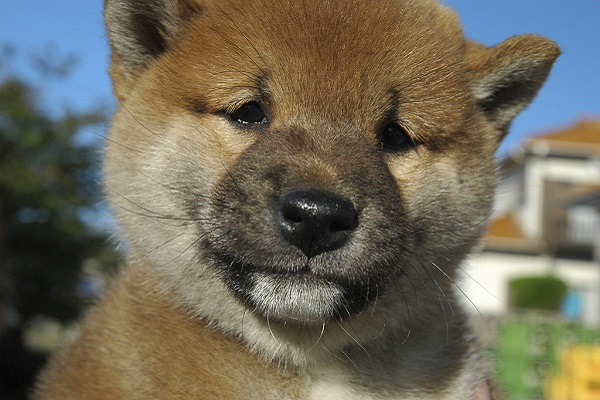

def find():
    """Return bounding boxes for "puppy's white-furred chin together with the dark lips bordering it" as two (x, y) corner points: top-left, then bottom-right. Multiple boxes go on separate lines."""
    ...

(213, 247), (381, 326)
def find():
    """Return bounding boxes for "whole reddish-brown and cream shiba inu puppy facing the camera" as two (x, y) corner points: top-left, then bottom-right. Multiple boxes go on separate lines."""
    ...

(37, 0), (559, 400)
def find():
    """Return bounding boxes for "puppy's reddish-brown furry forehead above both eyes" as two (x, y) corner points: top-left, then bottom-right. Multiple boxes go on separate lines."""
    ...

(173, 0), (464, 125)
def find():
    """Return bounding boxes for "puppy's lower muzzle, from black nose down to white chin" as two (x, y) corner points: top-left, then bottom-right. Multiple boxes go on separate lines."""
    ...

(196, 183), (405, 324)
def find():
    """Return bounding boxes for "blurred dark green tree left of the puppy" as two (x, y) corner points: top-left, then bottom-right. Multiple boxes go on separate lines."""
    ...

(0, 73), (117, 321)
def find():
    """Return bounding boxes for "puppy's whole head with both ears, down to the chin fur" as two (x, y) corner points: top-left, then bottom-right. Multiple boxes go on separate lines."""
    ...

(106, 0), (559, 360)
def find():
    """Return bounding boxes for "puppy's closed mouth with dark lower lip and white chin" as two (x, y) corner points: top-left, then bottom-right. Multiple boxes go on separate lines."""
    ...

(217, 256), (377, 324)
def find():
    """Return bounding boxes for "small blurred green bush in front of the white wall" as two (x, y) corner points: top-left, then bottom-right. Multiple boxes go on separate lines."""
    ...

(509, 275), (568, 311)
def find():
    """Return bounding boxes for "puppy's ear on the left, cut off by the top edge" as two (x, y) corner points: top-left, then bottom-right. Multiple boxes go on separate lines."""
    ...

(104, 0), (207, 100)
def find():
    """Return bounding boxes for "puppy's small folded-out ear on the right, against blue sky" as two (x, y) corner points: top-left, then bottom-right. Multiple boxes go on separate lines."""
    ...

(466, 35), (560, 138)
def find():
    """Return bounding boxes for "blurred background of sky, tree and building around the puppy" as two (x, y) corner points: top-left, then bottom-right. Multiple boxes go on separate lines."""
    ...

(0, 0), (600, 400)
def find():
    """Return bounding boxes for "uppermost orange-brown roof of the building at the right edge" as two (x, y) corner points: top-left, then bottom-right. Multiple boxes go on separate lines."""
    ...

(525, 118), (600, 156)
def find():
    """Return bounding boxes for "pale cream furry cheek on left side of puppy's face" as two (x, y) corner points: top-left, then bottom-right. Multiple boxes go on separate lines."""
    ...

(107, 110), (248, 274)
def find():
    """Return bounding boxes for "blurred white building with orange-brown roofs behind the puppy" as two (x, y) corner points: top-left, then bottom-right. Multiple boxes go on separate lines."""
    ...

(459, 119), (600, 325)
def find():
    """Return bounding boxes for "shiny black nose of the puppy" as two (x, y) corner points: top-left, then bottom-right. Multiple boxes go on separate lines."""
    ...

(279, 190), (358, 257)
